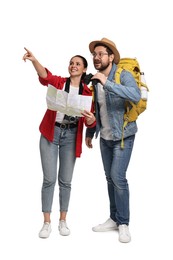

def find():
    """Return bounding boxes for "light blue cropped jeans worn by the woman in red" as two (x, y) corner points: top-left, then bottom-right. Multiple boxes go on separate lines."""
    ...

(40, 126), (77, 212)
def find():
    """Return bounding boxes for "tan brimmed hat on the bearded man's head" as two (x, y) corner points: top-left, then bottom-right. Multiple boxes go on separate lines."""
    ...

(89, 38), (120, 64)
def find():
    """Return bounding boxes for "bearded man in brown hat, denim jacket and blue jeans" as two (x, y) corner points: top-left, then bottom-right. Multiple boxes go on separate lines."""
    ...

(86, 38), (141, 243)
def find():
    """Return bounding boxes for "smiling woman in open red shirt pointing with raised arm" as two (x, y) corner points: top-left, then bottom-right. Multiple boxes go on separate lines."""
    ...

(23, 48), (96, 238)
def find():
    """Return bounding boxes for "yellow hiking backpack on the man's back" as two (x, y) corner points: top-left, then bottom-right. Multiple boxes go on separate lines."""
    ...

(115, 58), (149, 148)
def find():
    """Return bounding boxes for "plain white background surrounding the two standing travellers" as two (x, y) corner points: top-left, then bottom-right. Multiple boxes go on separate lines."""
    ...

(0, 0), (173, 260)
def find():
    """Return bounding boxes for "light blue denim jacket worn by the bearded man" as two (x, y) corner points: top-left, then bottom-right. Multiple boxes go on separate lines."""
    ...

(86, 63), (141, 141)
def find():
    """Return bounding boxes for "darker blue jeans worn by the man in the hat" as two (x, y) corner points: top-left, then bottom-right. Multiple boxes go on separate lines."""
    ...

(100, 135), (135, 225)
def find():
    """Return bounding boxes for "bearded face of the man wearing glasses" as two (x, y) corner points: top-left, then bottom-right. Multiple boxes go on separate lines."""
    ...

(92, 46), (112, 71)
